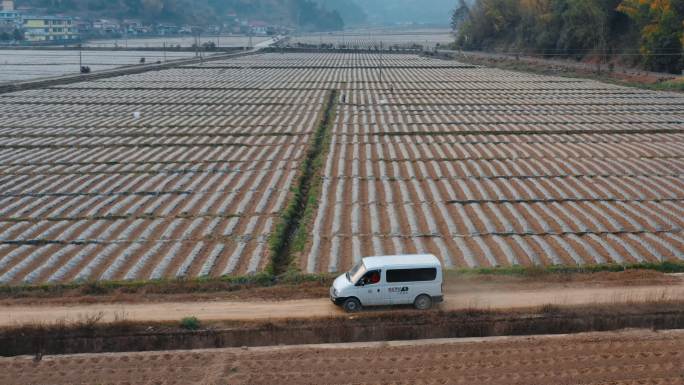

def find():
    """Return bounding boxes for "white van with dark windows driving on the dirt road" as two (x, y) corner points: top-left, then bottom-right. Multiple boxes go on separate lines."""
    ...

(330, 254), (444, 312)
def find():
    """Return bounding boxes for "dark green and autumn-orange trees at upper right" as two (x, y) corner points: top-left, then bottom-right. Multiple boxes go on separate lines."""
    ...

(452, 0), (684, 73)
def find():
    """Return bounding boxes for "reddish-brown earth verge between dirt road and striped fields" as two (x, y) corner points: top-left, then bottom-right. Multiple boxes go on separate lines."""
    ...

(0, 269), (672, 306)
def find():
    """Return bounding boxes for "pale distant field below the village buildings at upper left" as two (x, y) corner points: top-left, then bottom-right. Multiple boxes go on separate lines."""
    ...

(0, 49), (195, 84)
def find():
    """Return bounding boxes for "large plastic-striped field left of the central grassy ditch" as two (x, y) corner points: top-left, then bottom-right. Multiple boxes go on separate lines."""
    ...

(0, 58), (326, 283)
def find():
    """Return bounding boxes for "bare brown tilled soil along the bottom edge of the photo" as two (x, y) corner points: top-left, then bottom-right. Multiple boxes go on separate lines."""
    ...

(0, 330), (684, 385)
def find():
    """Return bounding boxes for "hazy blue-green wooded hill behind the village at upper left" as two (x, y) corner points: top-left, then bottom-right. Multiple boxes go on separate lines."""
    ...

(21, 0), (344, 30)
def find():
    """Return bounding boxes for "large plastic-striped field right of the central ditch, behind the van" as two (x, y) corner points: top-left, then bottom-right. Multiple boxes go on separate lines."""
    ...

(300, 55), (684, 272)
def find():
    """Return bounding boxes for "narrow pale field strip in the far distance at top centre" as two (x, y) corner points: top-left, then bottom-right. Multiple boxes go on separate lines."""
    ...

(288, 28), (454, 50)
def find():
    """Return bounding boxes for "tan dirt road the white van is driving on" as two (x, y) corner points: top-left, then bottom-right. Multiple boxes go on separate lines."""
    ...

(0, 283), (684, 326)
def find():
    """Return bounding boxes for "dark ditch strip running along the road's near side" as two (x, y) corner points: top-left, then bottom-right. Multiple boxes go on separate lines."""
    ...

(0, 302), (684, 356)
